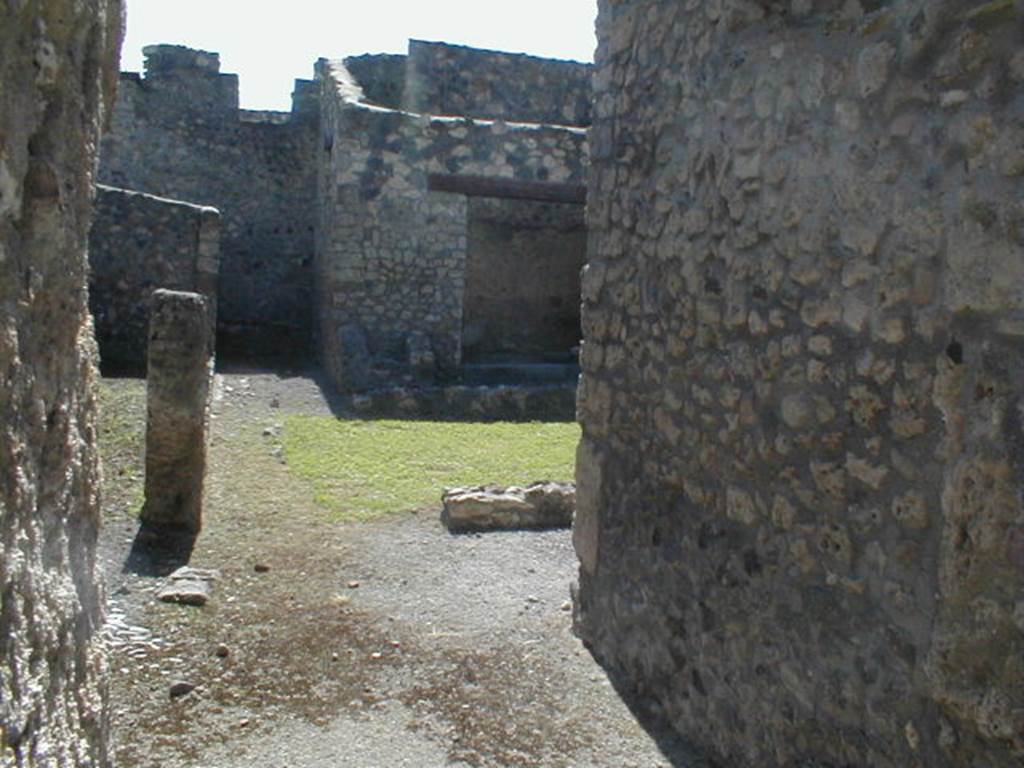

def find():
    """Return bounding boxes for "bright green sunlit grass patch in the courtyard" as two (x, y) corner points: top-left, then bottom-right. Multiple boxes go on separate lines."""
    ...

(282, 416), (580, 519)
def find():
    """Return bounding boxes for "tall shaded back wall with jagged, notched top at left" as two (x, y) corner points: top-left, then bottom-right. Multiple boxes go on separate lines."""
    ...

(100, 45), (319, 358)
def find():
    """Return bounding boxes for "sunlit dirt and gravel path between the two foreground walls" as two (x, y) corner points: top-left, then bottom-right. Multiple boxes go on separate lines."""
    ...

(101, 375), (699, 768)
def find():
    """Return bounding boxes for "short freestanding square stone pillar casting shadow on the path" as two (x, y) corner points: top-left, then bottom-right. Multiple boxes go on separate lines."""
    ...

(141, 291), (212, 534)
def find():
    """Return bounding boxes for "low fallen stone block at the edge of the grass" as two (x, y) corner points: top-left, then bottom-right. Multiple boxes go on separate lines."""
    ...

(441, 482), (575, 534)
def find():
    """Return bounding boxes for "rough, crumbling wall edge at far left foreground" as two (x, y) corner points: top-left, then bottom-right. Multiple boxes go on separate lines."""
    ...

(0, 0), (121, 768)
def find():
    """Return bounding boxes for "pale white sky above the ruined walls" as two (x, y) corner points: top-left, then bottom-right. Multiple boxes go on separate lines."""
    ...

(121, 0), (597, 110)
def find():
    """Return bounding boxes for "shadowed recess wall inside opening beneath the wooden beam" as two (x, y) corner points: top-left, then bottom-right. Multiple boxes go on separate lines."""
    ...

(462, 198), (587, 361)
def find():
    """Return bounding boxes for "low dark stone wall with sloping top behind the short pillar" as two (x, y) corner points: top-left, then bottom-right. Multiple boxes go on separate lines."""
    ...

(89, 185), (220, 372)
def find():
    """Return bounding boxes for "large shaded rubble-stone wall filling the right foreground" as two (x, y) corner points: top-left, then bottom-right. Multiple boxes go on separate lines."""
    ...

(574, 0), (1024, 768)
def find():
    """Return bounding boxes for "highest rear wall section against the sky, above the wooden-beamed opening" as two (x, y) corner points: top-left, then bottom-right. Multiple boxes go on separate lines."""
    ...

(404, 40), (593, 126)
